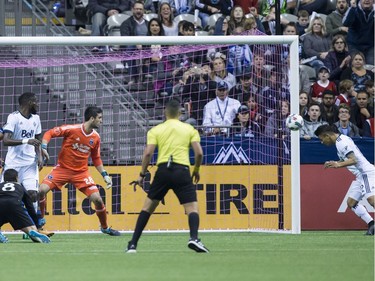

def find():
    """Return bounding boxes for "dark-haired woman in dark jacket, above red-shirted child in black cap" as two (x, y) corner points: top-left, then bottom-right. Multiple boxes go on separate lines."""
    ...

(323, 34), (350, 84)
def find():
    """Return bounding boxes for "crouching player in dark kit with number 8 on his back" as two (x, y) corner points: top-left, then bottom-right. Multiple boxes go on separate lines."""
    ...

(0, 169), (51, 243)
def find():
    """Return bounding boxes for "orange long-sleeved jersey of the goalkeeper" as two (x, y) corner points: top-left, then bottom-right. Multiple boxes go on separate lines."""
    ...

(43, 124), (102, 172)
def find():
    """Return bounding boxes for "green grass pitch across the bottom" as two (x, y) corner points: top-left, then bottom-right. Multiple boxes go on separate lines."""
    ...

(0, 231), (374, 281)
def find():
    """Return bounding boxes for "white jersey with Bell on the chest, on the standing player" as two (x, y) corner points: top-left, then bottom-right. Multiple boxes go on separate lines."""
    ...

(3, 111), (42, 168)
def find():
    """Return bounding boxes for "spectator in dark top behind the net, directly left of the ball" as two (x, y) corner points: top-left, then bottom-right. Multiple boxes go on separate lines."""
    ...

(264, 100), (290, 139)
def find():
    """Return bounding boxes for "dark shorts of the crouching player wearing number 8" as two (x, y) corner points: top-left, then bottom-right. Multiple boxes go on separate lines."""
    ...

(0, 199), (34, 230)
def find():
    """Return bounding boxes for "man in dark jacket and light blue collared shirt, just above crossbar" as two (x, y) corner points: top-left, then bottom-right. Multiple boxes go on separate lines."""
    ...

(120, 0), (148, 86)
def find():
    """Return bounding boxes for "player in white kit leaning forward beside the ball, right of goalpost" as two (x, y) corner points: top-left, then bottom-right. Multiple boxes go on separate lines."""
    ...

(315, 125), (375, 235)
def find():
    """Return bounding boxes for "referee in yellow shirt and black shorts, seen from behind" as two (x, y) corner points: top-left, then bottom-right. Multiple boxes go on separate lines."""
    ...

(127, 100), (209, 253)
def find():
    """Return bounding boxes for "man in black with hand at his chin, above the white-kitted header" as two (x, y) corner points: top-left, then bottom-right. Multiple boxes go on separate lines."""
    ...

(350, 90), (374, 136)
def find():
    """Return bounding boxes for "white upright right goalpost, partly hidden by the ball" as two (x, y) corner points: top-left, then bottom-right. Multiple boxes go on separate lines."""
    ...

(289, 39), (301, 234)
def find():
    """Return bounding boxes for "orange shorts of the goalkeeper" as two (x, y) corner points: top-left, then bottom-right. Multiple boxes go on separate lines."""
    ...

(42, 165), (99, 196)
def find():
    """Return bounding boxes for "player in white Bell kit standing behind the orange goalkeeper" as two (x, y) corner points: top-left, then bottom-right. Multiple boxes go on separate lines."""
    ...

(1, 93), (45, 211)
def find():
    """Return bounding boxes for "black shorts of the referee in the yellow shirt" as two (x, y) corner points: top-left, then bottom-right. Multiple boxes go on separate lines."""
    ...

(148, 163), (197, 204)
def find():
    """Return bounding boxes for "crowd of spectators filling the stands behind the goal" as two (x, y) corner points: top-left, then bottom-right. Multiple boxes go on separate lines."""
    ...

(44, 0), (375, 138)
